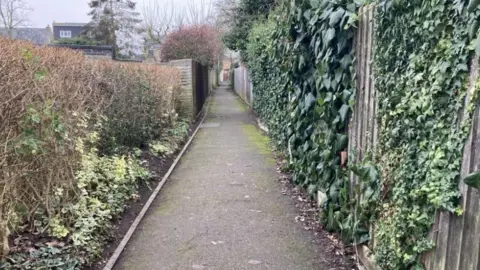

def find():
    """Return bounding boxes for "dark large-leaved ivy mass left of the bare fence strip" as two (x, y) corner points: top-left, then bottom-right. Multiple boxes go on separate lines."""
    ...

(247, 1), (356, 238)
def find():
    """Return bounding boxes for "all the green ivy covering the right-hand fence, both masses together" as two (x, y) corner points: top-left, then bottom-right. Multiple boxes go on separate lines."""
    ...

(240, 0), (480, 269)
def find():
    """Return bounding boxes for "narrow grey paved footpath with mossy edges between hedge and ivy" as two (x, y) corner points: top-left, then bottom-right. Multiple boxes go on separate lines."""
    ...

(115, 86), (328, 270)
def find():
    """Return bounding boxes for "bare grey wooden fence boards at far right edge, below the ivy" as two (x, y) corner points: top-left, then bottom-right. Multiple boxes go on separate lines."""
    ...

(424, 59), (480, 270)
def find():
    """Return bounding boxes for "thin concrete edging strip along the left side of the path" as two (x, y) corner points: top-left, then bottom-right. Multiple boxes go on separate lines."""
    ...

(103, 90), (214, 270)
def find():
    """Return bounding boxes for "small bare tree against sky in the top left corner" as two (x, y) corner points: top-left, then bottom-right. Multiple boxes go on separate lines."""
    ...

(0, 0), (32, 38)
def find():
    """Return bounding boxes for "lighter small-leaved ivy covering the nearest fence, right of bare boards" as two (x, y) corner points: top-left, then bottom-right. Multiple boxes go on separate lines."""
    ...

(374, 0), (475, 269)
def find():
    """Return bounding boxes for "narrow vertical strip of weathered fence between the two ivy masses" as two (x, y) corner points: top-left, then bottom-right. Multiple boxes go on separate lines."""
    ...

(347, 4), (379, 268)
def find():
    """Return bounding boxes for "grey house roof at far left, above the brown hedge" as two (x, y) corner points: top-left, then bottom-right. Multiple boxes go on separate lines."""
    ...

(0, 26), (53, 45)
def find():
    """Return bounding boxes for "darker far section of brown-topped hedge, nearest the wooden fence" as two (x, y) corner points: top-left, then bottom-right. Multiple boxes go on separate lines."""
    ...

(96, 60), (180, 150)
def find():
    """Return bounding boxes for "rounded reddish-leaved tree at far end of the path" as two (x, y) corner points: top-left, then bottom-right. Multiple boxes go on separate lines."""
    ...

(161, 25), (222, 66)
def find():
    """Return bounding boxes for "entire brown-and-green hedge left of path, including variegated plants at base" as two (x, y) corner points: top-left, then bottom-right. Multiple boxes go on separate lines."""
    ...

(0, 39), (180, 269)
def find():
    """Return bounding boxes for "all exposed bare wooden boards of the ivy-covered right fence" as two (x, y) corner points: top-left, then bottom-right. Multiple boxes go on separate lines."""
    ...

(348, 5), (480, 270)
